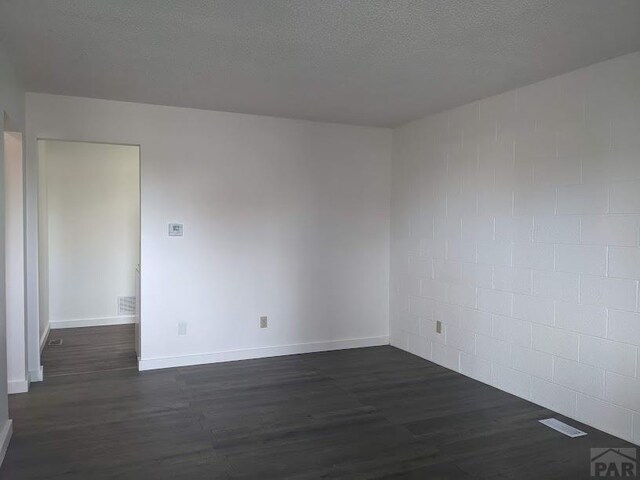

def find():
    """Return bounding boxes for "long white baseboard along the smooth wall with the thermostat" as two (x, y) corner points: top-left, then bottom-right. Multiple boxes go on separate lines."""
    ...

(138, 336), (389, 371)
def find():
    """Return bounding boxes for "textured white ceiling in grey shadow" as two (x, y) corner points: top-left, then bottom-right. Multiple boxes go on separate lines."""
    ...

(0, 0), (640, 126)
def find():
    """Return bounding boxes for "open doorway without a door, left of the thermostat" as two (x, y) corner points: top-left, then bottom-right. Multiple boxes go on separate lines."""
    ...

(38, 140), (140, 376)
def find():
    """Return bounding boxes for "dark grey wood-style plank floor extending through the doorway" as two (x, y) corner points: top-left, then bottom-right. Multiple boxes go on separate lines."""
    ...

(0, 327), (630, 480)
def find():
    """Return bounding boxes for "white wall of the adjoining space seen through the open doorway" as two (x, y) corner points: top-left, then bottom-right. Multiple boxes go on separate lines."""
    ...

(39, 140), (140, 328)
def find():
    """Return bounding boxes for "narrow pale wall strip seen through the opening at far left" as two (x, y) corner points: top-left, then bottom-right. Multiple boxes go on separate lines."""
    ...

(4, 133), (29, 393)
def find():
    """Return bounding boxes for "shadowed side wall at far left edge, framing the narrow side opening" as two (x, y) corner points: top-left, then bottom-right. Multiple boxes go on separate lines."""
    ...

(0, 48), (24, 462)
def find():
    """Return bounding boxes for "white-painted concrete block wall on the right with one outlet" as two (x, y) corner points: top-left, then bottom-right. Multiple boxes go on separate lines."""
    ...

(390, 52), (640, 444)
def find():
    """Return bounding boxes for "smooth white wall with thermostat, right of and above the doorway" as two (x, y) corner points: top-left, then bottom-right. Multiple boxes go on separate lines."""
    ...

(26, 94), (391, 368)
